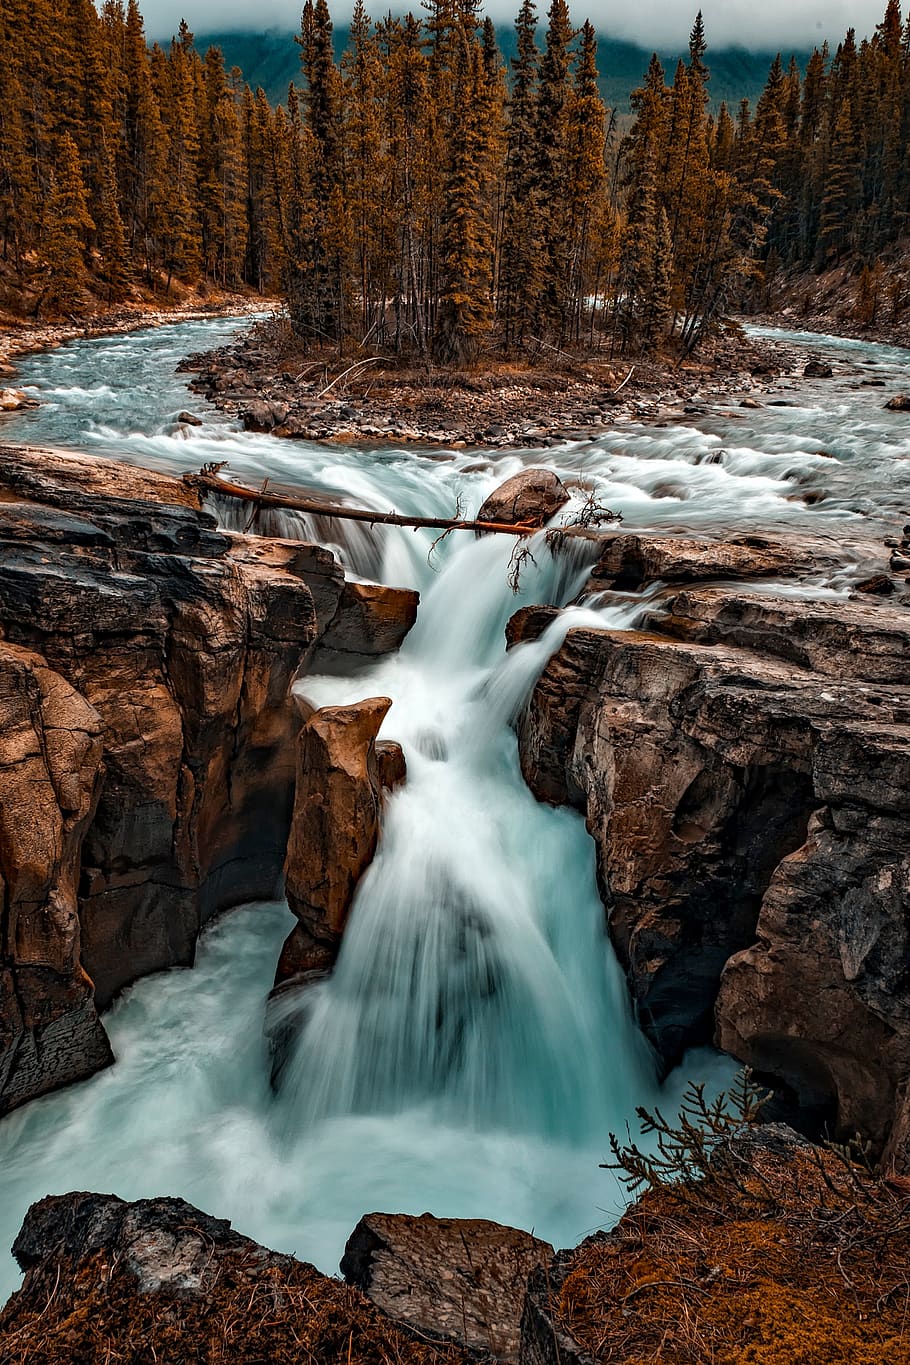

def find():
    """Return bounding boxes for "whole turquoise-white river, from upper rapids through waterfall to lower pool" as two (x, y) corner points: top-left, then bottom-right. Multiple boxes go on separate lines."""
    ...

(0, 319), (910, 1299)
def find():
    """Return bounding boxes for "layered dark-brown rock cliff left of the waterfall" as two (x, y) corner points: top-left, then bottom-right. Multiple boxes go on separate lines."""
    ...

(0, 448), (407, 1112)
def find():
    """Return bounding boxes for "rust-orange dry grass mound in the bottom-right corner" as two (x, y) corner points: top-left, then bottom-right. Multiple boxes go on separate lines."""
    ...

(555, 1145), (910, 1365)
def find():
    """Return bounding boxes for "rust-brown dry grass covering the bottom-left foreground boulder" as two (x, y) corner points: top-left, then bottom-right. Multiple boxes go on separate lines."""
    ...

(0, 1252), (464, 1365)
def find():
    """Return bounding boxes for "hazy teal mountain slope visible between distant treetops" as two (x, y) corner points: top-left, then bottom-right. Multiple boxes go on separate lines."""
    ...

(196, 27), (809, 115)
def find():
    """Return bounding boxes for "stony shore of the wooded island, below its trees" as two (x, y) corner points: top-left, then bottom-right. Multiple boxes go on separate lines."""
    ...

(180, 319), (810, 449)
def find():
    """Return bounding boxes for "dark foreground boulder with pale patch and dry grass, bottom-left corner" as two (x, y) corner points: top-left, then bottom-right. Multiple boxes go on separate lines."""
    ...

(0, 1194), (465, 1365)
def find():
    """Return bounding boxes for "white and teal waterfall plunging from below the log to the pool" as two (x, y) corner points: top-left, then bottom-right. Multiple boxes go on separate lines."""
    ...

(280, 536), (654, 1141)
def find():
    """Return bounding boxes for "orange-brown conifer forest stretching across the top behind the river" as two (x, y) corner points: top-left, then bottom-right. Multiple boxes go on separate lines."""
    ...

(0, 0), (910, 363)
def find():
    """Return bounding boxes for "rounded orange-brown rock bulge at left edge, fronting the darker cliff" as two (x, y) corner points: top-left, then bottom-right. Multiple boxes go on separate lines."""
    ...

(0, 643), (112, 1114)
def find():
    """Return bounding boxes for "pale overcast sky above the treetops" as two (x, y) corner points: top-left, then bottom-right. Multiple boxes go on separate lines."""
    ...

(139, 0), (885, 51)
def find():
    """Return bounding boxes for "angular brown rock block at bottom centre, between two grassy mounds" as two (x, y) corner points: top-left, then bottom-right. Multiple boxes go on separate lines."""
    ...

(341, 1213), (553, 1361)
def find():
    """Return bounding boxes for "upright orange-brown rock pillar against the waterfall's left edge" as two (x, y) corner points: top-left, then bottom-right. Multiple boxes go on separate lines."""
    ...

(276, 698), (392, 984)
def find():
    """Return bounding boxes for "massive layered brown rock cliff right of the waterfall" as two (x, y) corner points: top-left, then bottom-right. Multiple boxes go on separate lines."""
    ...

(517, 537), (910, 1164)
